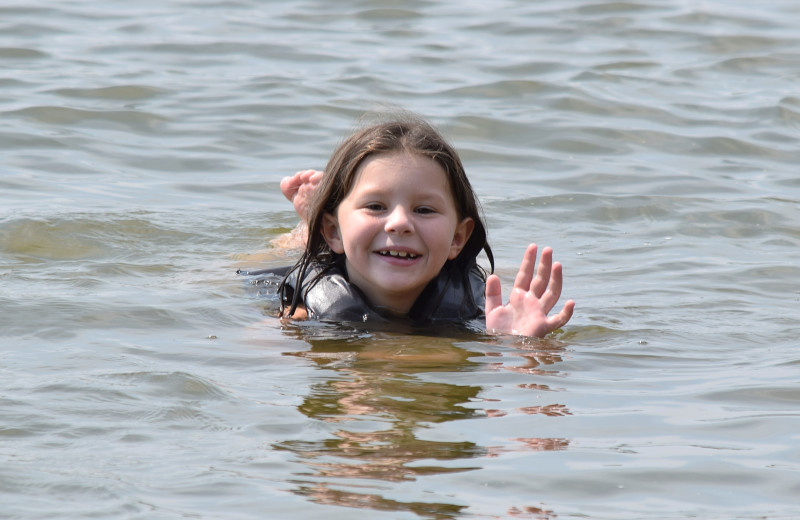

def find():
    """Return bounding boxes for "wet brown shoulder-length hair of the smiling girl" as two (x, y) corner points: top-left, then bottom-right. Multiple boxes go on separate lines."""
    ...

(279, 112), (494, 316)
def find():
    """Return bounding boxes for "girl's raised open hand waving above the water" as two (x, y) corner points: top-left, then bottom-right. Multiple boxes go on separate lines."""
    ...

(486, 244), (575, 338)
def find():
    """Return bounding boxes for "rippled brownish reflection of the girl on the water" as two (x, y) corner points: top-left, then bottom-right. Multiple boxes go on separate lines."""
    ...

(275, 329), (570, 518)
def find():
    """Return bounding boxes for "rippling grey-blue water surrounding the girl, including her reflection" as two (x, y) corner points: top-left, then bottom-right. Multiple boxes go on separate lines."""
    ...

(0, 0), (800, 520)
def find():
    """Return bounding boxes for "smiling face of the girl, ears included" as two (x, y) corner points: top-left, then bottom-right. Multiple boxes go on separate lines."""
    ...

(322, 152), (475, 314)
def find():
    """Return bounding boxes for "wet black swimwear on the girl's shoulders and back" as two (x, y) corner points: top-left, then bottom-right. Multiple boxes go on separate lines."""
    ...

(239, 262), (486, 323)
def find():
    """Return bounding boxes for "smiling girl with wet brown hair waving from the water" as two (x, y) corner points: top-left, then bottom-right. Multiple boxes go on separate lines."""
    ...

(278, 114), (574, 337)
